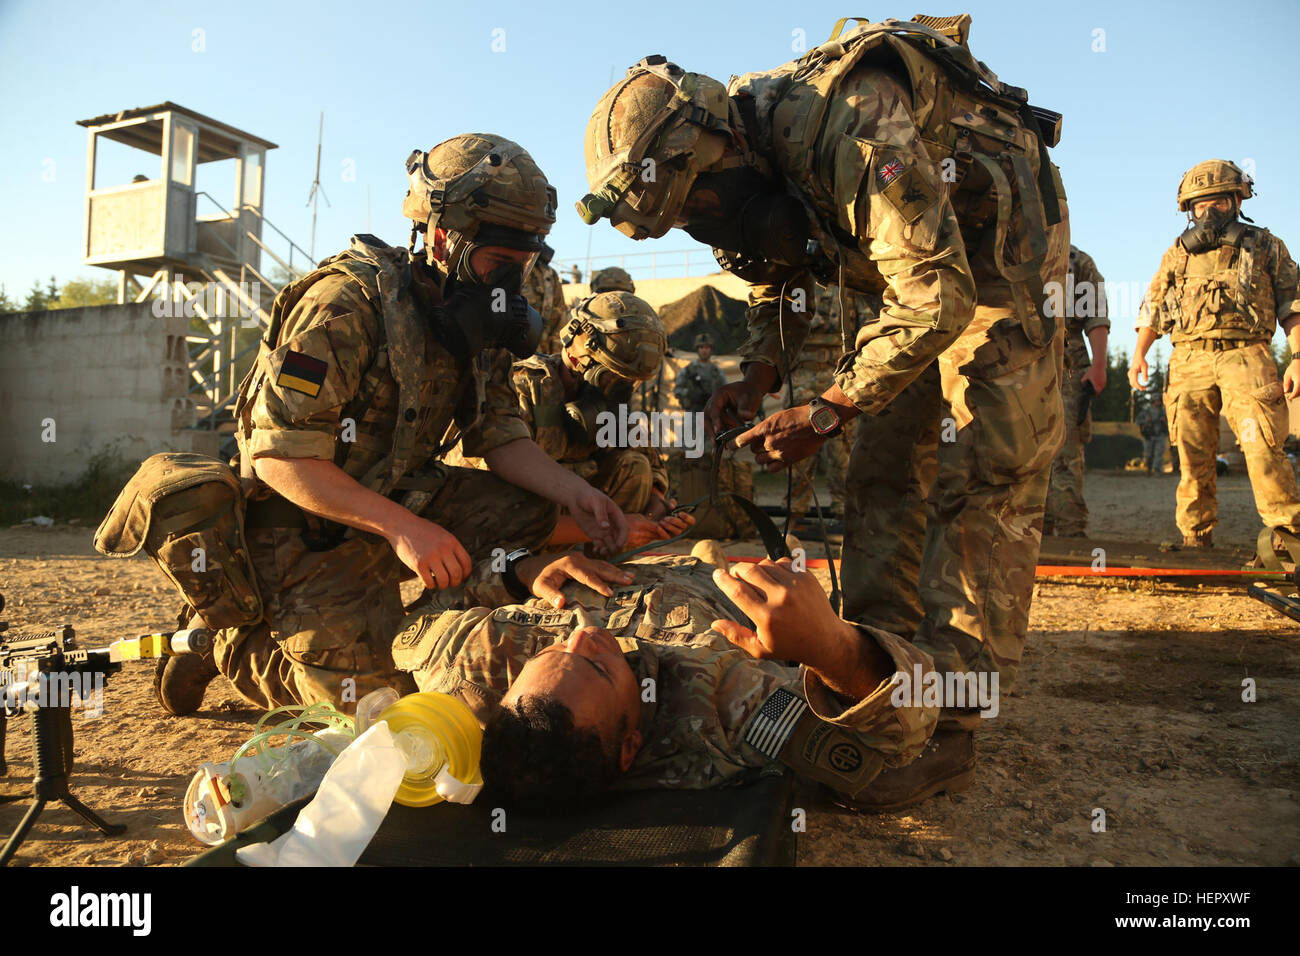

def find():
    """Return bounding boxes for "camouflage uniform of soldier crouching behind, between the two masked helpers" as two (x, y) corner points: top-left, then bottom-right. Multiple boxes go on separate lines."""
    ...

(511, 355), (668, 514)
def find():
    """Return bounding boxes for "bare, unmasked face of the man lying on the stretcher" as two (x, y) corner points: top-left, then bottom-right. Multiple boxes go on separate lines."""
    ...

(501, 627), (641, 762)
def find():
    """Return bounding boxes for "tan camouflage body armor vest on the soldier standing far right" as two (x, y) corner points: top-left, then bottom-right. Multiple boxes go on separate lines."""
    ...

(1158, 221), (1277, 343)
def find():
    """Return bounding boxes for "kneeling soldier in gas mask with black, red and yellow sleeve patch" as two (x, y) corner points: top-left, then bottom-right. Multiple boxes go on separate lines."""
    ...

(156, 134), (625, 714)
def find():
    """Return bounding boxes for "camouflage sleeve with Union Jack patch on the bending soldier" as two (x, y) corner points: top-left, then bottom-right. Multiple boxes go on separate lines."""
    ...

(819, 63), (975, 414)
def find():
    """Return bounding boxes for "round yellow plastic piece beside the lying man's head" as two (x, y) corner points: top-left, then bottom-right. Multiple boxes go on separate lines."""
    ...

(377, 692), (484, 806)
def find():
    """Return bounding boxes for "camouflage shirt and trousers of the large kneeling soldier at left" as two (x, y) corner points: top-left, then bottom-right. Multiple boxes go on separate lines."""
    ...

(226, 237), (556, 708)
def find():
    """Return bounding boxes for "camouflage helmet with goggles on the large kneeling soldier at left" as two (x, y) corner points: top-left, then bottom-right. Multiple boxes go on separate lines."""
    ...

(402, 133), (555, 281)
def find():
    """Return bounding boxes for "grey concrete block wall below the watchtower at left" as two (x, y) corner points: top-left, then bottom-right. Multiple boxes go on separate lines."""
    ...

(0, 302), (216, 484)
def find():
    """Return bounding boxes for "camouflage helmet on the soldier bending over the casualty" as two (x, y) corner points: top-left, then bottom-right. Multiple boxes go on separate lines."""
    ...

(577, 56), (732, 239)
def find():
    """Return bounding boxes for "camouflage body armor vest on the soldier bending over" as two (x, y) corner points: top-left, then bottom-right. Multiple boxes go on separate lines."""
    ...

(728, 16), (1063, 341)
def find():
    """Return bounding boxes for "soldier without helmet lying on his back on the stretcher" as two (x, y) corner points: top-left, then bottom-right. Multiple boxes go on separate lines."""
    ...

(393, 548), (941, 810)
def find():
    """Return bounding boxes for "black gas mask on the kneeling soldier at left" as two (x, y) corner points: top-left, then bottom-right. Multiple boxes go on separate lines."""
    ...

(438, 263), (542, 360)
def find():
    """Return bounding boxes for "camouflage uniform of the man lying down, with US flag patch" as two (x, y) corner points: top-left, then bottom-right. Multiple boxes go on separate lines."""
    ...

(393, 557), (937, 795)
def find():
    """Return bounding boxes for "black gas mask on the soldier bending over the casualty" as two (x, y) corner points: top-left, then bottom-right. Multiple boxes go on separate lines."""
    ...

(683, 166), (810, 265)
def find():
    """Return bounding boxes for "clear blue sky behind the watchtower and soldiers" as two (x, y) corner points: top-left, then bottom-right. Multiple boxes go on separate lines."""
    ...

(0, 0), (1300, 358)
